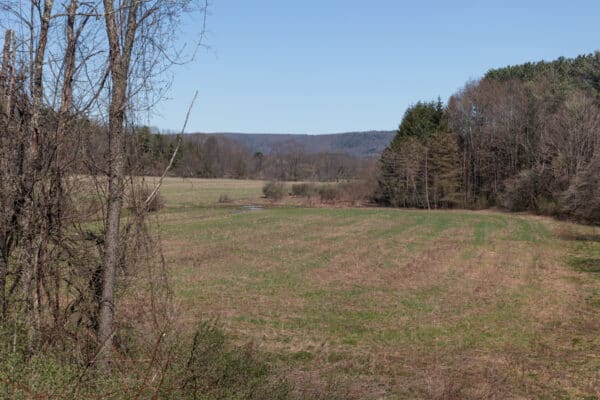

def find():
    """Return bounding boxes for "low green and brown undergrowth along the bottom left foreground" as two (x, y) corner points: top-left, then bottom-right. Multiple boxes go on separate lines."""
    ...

(0, 322), (346, 400)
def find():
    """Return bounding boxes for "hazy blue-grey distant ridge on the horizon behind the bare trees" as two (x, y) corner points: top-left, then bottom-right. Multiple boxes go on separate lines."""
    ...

(187, 131), (396, 158)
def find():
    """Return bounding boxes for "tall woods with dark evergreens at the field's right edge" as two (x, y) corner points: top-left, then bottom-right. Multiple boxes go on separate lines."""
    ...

(374, 53), (600, 224)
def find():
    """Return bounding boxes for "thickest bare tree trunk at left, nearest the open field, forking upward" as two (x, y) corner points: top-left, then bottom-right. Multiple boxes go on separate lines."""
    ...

(98, 0), (207, 367)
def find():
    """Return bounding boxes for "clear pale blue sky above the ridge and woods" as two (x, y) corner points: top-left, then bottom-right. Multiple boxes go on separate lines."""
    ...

(149, 0), (600, 133)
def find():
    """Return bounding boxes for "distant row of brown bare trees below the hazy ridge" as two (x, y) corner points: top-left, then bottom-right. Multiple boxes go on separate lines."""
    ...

(129, 127), (375, 181)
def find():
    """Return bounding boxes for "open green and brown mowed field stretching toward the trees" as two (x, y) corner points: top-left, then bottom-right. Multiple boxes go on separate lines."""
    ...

(151, 178), (600, 399)
